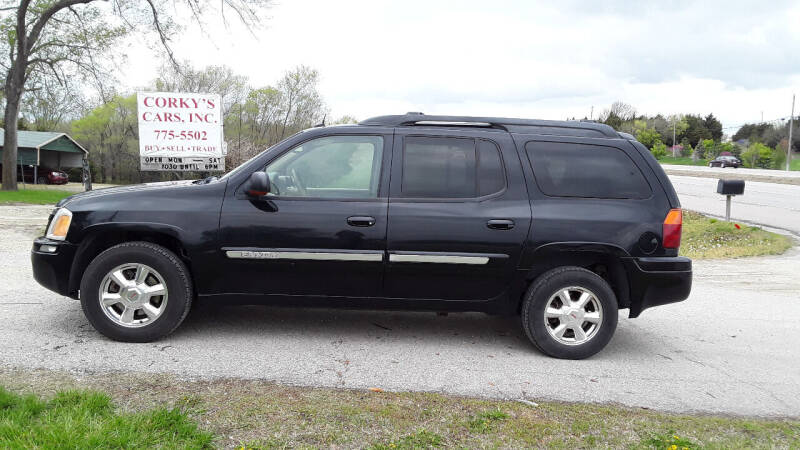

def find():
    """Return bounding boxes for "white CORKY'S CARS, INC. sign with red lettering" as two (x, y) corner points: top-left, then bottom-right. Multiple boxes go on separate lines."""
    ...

(137, 92), (225, 172)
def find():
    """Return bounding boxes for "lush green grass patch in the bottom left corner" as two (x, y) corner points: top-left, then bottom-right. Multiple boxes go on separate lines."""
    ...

(0, 387), (211, 449)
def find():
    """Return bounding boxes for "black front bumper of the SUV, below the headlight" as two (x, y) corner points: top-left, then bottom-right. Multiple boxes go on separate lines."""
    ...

(31, 237), (78, 295)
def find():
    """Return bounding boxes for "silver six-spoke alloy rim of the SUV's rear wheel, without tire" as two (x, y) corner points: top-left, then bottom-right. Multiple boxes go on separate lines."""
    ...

(544, 286), (603, 345)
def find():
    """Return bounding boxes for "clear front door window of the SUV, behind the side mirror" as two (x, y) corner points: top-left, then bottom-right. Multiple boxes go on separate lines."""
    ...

(265, 136), (383, 198)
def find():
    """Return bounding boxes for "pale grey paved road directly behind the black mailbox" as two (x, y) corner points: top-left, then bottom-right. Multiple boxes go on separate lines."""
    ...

(669, 174), (800, 236)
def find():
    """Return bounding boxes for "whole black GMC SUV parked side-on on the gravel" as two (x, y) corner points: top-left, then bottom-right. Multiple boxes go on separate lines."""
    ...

(32, 113), (692, 358)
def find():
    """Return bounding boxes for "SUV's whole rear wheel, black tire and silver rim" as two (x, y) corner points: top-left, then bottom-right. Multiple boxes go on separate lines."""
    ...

(522, 266), (618, 359)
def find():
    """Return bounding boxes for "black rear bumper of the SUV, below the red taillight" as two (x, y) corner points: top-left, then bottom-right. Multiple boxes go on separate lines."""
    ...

(624, 256), (692, 317)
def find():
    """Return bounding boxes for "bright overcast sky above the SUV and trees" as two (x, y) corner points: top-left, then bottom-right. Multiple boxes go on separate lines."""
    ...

(122, 0), (800, 134)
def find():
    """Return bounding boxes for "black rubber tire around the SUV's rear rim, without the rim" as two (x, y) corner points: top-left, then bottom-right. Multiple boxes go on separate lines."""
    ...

(522, 266), (619, 359)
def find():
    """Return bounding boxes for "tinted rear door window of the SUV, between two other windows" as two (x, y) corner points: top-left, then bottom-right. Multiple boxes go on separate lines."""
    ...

(401, 136), (506, 198)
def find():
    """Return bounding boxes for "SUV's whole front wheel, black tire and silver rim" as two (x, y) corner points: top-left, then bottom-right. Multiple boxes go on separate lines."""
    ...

(81, 242), (192, 342)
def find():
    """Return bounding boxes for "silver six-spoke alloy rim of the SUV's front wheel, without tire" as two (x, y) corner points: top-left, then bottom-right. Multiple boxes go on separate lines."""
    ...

(98, 263), (167, 328)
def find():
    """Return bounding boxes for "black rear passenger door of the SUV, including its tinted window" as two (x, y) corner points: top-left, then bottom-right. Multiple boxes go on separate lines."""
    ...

(384, 128), (531, 301)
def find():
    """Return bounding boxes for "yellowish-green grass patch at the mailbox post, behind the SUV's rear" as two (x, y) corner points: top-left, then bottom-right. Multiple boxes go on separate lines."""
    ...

(680, 211), (792, 259)
